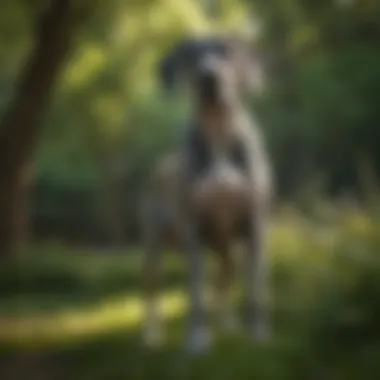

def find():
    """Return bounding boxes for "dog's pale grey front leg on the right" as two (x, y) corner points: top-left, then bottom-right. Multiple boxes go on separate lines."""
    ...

(236, 129), (272, 340)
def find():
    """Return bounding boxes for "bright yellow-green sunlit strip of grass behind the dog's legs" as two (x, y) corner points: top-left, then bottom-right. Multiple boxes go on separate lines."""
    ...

(0, 291), (186, 347)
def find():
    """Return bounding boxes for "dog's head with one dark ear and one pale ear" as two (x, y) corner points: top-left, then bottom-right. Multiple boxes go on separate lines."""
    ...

(160, 36), (262, 106)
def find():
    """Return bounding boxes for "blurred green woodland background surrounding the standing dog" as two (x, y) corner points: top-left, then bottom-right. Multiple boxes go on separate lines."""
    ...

(0, 0), (380, 380)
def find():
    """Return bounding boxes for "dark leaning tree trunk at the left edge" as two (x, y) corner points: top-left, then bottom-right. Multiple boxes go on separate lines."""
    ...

(0, 0), (74, 257)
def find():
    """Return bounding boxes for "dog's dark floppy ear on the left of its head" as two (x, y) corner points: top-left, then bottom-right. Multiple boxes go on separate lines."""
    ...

(158, 38), (197, 90)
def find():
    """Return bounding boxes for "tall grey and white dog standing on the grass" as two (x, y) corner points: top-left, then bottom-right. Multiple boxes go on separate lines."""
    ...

(143, 35), (273, 353)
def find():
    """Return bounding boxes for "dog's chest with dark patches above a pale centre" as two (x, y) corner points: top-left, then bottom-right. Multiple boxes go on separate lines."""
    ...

(191, 125), (249, 231)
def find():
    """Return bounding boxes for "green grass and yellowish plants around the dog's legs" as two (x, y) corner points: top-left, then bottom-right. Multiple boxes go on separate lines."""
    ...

(0, 205), (380, 380)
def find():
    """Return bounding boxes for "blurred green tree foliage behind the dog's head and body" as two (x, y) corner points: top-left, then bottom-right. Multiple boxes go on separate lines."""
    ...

(0, 0), (380, 241)
